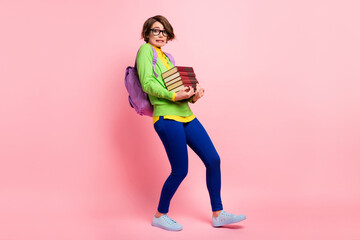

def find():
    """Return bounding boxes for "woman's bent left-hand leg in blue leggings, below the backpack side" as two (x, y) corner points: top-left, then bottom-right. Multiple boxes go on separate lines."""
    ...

(154, 117), (188, 213)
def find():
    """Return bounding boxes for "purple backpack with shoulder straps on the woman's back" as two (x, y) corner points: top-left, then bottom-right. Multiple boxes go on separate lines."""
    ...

(125, 46), (175, 117)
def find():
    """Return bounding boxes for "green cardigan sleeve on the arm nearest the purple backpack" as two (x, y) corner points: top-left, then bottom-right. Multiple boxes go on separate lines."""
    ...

(136, 44), (174, 101)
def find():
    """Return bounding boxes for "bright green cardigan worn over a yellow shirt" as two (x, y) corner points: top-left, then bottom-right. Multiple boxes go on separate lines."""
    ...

(136, 43), (193, 117)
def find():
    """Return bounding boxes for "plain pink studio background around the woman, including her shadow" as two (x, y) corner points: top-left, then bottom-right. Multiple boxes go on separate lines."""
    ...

(0, 0), (360, 240)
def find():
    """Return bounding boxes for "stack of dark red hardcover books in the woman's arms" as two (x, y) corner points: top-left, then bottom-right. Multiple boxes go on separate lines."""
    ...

(161, 66), (198, 92)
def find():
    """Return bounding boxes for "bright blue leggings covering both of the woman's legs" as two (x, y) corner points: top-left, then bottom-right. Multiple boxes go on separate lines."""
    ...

(154, 117), (223, 213)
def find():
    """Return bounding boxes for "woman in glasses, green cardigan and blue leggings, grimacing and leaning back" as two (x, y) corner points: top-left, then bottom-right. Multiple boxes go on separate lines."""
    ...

(136, 15), (246, 231)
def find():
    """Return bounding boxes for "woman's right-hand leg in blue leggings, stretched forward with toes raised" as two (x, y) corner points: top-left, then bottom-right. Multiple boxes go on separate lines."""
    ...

(184, 118), (223, 211)
